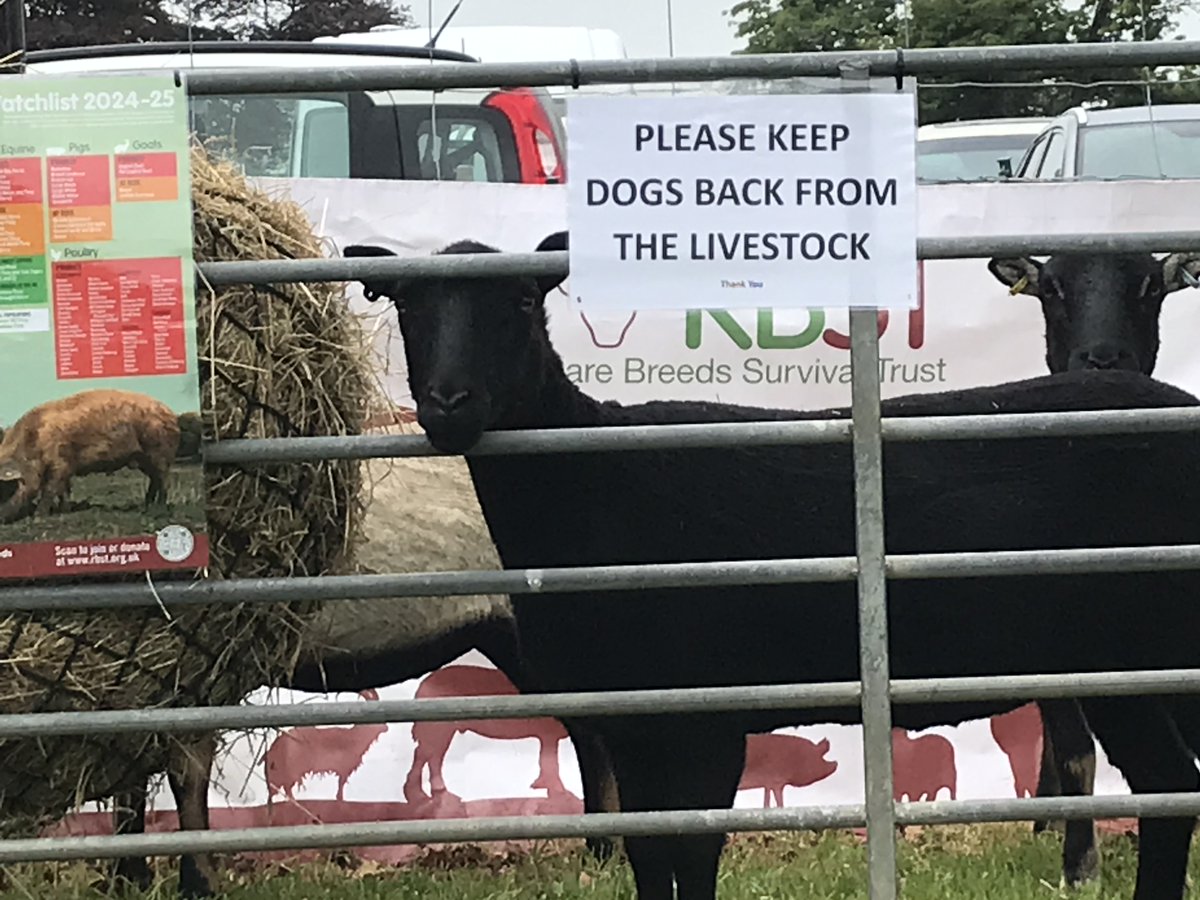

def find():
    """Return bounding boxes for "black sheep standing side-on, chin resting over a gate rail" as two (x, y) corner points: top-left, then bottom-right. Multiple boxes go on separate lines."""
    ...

(346, 234), (1200, 900)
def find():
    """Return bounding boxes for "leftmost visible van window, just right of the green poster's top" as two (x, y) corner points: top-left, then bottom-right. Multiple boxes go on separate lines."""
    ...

(191, 94), (350, 178)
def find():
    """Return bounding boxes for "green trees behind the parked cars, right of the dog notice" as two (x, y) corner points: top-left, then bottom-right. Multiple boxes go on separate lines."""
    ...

(730, 0), (1196, 122)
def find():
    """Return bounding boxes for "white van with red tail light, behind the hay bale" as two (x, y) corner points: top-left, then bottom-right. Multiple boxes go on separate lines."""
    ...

(26, 41), (566, 184)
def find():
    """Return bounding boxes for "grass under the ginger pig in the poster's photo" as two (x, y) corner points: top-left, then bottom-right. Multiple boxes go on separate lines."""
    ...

(0, 463), (206, 544)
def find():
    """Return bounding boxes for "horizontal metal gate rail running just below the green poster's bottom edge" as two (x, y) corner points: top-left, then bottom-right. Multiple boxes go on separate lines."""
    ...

(0, 544), (1200, 612)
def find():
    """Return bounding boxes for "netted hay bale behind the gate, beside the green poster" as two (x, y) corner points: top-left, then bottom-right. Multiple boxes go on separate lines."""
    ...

(0, 150), (374, 834)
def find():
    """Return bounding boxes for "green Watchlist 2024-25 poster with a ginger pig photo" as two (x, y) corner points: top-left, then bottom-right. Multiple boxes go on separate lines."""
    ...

(0, 74), (208, 578)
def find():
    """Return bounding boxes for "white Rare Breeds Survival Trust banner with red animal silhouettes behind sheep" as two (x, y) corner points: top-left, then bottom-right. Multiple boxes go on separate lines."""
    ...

(51, 180), (1200, 862)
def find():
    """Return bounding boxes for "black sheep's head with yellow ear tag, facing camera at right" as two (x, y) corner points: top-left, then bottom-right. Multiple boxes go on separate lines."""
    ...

(988, 253), (1200, 374)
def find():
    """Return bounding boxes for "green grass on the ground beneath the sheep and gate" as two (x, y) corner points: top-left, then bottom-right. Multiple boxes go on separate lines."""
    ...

(0, 823), (1185, 900)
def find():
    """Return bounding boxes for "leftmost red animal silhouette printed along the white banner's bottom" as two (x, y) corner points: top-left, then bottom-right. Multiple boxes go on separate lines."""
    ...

(265, 689), (388, 804)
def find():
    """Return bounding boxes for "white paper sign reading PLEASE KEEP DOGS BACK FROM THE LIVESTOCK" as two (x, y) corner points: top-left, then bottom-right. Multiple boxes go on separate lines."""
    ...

(568, 94), (917, 311)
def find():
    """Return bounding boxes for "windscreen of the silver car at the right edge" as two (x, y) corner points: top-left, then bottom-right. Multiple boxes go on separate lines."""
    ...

(1076, 119), (1200, 179)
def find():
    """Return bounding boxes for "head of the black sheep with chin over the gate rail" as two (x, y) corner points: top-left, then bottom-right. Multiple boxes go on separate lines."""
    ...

(343, 232), (566, 454)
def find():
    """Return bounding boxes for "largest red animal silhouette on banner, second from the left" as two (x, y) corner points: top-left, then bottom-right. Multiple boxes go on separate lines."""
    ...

(404, 666), (568, 803)
